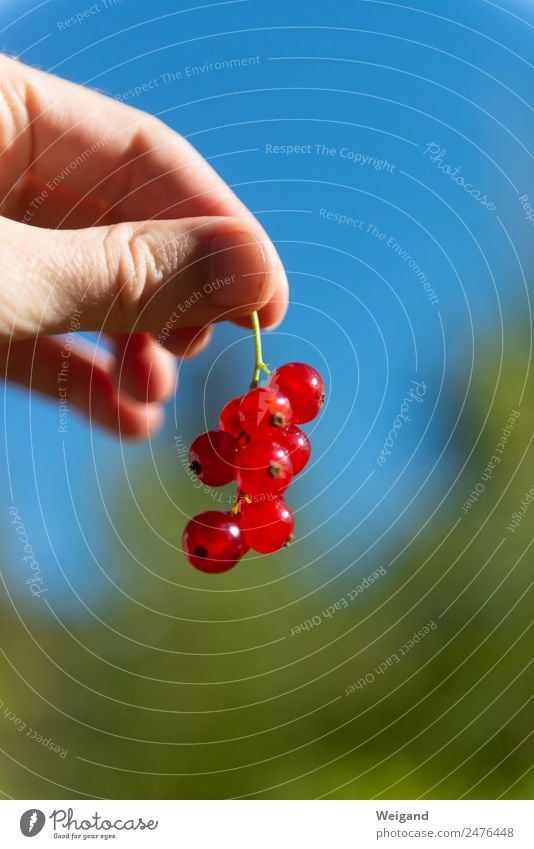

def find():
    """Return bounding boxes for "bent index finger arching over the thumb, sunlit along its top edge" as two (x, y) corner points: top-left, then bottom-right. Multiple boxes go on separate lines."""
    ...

(0, 56), (287, 330)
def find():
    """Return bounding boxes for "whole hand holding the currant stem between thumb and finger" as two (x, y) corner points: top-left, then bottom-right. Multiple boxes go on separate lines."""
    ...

(0, 56), (287, 437)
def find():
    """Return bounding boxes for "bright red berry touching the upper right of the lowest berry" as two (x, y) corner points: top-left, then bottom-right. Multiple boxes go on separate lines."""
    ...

(239, 496), (295, 554)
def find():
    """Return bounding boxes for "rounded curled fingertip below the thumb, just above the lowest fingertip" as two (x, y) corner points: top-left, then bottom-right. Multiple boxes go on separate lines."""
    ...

(112, 333), (176, 403)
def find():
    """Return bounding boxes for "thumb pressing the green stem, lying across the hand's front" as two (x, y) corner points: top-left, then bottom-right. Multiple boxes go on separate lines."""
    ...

(0, 217), (287, 341)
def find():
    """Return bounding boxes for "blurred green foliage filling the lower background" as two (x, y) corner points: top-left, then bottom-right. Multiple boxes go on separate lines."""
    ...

(0, 338), (534, 798)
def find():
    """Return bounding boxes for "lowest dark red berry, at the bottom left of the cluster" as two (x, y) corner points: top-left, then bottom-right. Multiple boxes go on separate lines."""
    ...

(182, 510), (247, 572)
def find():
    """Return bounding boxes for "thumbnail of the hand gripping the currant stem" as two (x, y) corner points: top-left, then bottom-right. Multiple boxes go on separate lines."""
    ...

(206, 231), (267, 309)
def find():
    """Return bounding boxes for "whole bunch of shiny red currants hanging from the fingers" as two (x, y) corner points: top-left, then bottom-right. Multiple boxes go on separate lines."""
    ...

(183, 361), (325, 572)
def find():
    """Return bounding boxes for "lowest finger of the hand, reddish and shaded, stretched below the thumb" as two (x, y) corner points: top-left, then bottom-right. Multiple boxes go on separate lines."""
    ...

(0, 337), (163, 439)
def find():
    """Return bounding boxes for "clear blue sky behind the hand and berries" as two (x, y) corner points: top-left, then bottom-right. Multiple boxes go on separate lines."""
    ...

(0, 0), (534, 609)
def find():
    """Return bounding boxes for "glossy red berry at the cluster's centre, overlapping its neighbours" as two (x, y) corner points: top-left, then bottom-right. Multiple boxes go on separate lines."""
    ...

(235, 439), (293, 495)
